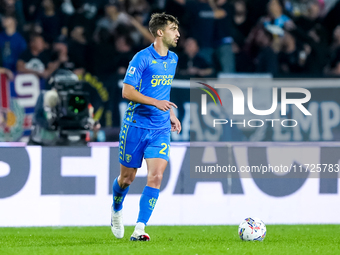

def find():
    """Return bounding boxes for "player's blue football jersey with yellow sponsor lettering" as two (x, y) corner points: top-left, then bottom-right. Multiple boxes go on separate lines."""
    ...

(123, 44), (178, 129)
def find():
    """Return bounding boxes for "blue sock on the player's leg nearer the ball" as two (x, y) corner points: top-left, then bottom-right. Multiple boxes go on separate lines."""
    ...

(137, 186), (159, 225)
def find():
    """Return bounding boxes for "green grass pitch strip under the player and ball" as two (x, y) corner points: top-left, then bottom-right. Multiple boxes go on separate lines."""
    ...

(0, 225), (340, 255)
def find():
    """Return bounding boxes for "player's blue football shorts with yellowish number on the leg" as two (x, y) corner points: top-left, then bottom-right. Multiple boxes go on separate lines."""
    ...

(119, 124), (170, 168)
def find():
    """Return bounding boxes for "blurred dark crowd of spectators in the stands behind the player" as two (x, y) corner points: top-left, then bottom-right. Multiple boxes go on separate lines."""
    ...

(0, 0), (340, 79)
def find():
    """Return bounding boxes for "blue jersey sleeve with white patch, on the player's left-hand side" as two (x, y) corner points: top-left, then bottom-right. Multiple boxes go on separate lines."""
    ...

(123, 53), (147, 87)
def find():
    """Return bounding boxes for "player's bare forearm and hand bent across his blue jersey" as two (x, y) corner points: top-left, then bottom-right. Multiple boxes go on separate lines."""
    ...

(122, 83), (177, 111)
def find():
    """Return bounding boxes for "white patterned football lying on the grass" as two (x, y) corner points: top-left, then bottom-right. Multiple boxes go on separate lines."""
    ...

(238, 217), (267, 241)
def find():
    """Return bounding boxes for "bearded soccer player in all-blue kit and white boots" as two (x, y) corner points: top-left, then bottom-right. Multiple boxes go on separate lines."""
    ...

(111, 13), (181, 241)
